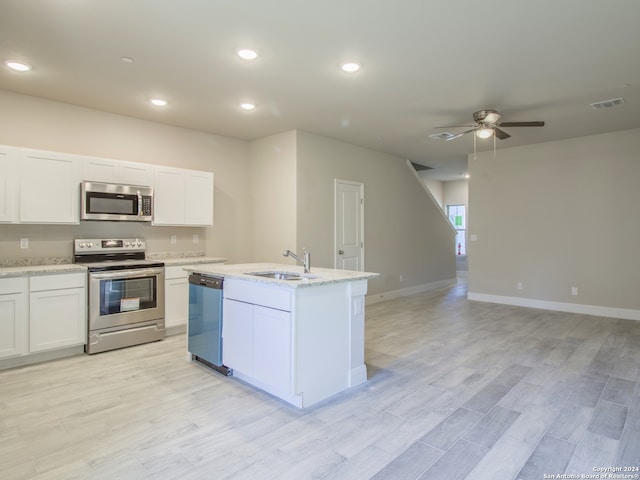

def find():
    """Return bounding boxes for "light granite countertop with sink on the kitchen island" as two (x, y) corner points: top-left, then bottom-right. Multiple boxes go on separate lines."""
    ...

(185, 263), (380, 288)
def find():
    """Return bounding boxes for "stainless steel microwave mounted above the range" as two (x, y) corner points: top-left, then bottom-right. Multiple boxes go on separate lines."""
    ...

(80, 182), (153, 222)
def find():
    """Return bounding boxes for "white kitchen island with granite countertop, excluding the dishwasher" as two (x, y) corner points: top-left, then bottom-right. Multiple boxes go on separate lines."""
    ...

(182, 263), (378, 408)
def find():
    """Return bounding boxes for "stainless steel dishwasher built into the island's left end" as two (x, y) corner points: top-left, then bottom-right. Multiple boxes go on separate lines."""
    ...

(187, 273), (231, 375)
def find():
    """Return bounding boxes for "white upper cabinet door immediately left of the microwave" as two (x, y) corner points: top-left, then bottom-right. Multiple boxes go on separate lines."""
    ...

(19, 150), (80, 224)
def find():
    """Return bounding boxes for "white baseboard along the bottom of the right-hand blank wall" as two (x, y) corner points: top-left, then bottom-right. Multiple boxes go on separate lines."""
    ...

(467, 292), (640, 320)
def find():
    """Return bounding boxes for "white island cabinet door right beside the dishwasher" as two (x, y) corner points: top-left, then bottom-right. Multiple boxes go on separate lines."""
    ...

(222, 298), (253, 376)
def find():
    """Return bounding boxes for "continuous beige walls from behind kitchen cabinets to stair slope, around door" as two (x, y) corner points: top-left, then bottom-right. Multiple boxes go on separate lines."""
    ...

(0, 91), (455, 300)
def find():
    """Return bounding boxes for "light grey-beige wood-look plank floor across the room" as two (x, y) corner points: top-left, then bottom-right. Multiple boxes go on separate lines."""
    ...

(0, 284), (640, 480)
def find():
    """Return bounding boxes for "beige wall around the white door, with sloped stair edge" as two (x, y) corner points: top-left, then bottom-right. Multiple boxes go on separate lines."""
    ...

(297, 131), (456, 294)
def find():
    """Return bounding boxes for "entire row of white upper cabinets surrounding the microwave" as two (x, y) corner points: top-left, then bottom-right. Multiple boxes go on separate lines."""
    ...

(0, 145), (214, 227)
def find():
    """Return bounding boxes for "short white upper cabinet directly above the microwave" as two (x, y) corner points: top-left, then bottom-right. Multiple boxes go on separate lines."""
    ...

(82, 157), (153, 187)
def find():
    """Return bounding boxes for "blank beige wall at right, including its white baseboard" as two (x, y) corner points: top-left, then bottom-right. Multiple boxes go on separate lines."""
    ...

(468, 125), (640, 319)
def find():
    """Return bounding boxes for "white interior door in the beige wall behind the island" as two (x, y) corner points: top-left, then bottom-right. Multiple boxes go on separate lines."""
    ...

(334, 179), (364, 272)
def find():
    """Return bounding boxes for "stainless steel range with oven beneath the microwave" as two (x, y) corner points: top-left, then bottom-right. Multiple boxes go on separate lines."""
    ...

(73, 238), (164, 354)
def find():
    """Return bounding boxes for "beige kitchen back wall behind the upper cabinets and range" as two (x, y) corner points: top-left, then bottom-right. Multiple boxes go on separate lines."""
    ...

(0, 90), (252, 262)
